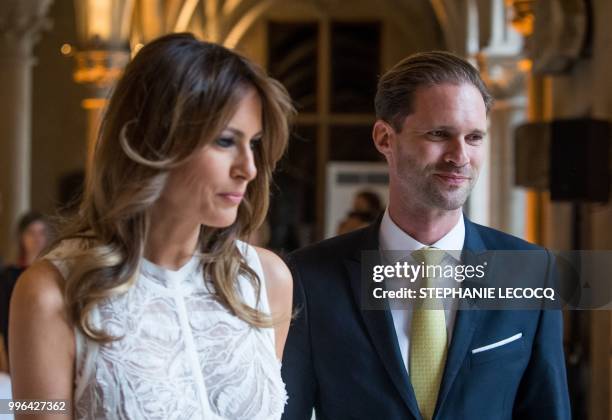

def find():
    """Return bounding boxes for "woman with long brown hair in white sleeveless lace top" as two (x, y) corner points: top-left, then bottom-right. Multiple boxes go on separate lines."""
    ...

(10, 34), (292, 419)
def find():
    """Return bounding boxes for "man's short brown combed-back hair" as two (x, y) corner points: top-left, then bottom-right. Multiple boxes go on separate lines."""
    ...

(374, 51), (493, 132)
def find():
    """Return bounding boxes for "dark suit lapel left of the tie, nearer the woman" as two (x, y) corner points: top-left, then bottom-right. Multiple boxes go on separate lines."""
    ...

(344, 219), (420, 418)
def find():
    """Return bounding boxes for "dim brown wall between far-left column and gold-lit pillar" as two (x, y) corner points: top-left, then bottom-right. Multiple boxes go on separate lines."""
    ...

(31, 0), (86, 217)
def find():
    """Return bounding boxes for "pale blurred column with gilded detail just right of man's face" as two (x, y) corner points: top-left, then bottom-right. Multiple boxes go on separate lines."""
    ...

(468, 0), (528, 236)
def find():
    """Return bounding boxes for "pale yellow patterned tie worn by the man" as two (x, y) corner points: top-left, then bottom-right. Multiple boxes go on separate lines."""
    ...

(409, 247), (447, 420)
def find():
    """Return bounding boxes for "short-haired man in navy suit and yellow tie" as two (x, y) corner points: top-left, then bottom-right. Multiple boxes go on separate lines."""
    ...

(283, 52), (570, 420)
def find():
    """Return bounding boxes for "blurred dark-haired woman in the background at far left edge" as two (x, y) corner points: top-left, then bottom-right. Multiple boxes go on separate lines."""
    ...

(0, 211), (50, 349)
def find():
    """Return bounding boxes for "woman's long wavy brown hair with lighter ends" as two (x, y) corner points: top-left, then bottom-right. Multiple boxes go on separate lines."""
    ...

(50, 34), (294, 341)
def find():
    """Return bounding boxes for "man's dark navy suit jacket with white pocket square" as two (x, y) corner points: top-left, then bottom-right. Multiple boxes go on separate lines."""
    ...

(282, 218), (570, 420)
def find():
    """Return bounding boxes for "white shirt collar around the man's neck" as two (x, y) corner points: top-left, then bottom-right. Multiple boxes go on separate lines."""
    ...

(379, 207), (465, 251)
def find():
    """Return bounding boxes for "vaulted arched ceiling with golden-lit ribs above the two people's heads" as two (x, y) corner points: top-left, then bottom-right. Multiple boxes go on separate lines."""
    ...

(126, 0), (454, 52)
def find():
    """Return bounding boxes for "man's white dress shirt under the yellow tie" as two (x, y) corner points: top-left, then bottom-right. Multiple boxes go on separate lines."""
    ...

(378, 208), (465, 374)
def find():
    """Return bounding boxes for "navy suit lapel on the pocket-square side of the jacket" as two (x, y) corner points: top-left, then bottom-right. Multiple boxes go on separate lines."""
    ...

(437, 218), (486, 414)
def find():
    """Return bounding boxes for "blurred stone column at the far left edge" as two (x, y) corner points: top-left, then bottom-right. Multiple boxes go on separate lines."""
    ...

(0, 0), (52, 259)
